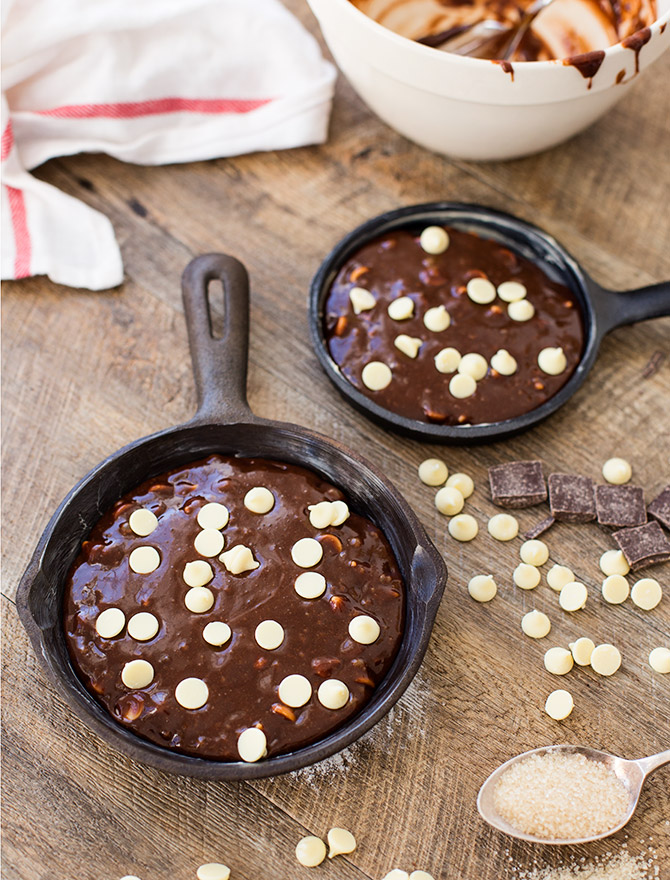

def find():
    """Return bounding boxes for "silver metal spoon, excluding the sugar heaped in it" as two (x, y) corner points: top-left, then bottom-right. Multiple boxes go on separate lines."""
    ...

(477, 746), (670, 844)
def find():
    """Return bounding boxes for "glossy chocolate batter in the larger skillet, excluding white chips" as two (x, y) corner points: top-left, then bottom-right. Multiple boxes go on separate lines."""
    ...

(64, 456), (404, 761)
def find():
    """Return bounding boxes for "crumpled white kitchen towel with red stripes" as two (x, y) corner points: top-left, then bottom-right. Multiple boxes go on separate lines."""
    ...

(2, 0), (335, 290)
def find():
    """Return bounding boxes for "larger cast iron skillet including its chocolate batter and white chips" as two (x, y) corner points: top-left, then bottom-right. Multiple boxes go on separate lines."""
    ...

(17, 254), (446, 779)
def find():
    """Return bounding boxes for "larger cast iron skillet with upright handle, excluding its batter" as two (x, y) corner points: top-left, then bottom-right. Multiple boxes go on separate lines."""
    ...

(17, 254), (447, 779)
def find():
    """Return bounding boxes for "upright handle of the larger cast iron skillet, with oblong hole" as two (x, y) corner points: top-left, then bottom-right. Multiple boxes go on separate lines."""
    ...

(181, 254), (254, 423)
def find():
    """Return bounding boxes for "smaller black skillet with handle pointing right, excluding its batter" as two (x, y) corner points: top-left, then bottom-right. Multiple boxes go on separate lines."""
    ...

(309, 202), (670, 444)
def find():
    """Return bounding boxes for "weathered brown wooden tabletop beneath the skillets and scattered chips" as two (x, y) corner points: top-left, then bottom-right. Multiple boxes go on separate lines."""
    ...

(2, 0), (670, 880)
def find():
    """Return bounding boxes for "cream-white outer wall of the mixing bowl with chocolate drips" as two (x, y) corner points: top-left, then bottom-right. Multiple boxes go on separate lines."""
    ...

(308, 0), (670, 160)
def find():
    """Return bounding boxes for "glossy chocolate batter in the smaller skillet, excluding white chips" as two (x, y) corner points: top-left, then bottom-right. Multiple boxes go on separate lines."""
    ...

(324, 227), (584, 425)
